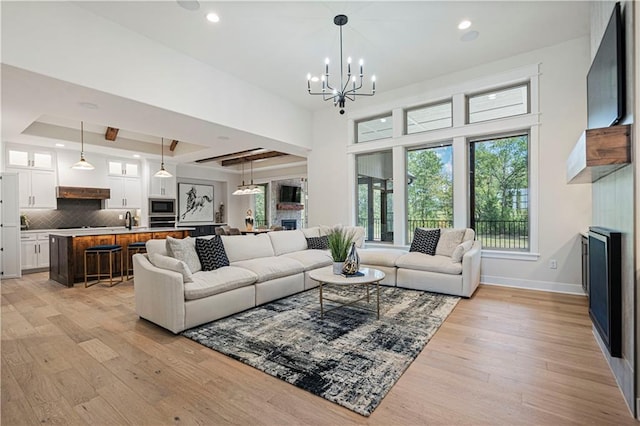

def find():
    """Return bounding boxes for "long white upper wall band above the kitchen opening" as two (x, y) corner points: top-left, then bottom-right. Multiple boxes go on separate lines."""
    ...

(2, 2), (311, 148)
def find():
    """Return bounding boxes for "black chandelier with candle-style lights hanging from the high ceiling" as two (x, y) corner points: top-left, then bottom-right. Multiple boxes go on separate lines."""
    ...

(307, 15), (376, 114)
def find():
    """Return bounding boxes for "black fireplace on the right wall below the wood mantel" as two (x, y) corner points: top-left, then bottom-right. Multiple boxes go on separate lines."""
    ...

(589, 226), (622, 357)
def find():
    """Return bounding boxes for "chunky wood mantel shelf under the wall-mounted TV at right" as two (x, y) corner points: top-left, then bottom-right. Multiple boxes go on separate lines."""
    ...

(567, 124), (631, 183)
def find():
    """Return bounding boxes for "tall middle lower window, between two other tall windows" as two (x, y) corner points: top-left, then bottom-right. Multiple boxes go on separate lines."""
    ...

(407, 145), (453, 242)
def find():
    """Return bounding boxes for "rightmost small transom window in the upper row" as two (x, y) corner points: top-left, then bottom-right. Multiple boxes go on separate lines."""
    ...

(467, 84), (529, 123)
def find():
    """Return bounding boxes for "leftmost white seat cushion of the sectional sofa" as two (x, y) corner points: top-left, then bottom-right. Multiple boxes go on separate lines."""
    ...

(184, 266), (257, 300)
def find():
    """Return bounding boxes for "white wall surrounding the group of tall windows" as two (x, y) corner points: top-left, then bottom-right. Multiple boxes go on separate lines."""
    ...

(308, 37), (591, 292)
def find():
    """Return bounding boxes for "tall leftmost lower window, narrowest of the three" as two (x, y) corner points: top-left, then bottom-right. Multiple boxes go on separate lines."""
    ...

(356, 151), (393, 241)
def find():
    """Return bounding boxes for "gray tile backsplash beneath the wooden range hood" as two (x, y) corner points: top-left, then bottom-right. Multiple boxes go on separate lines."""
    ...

(20, 199), (135, 230)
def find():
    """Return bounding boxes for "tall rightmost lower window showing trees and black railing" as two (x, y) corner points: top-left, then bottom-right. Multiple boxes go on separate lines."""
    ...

(469, 134), (529, 251)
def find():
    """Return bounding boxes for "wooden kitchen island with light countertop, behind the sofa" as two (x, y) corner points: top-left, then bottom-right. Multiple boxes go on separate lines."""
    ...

(49, 227), (195, 287)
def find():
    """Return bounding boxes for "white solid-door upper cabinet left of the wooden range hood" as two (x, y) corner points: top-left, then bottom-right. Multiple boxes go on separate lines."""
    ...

(6, 168), (57, 209)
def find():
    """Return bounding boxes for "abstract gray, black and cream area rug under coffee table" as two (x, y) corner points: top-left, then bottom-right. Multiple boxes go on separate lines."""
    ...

(182, 286), (460, 416)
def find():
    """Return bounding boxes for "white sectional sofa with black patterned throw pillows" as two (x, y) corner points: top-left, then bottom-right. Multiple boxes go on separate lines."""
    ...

(133, 227), (481, 333)
